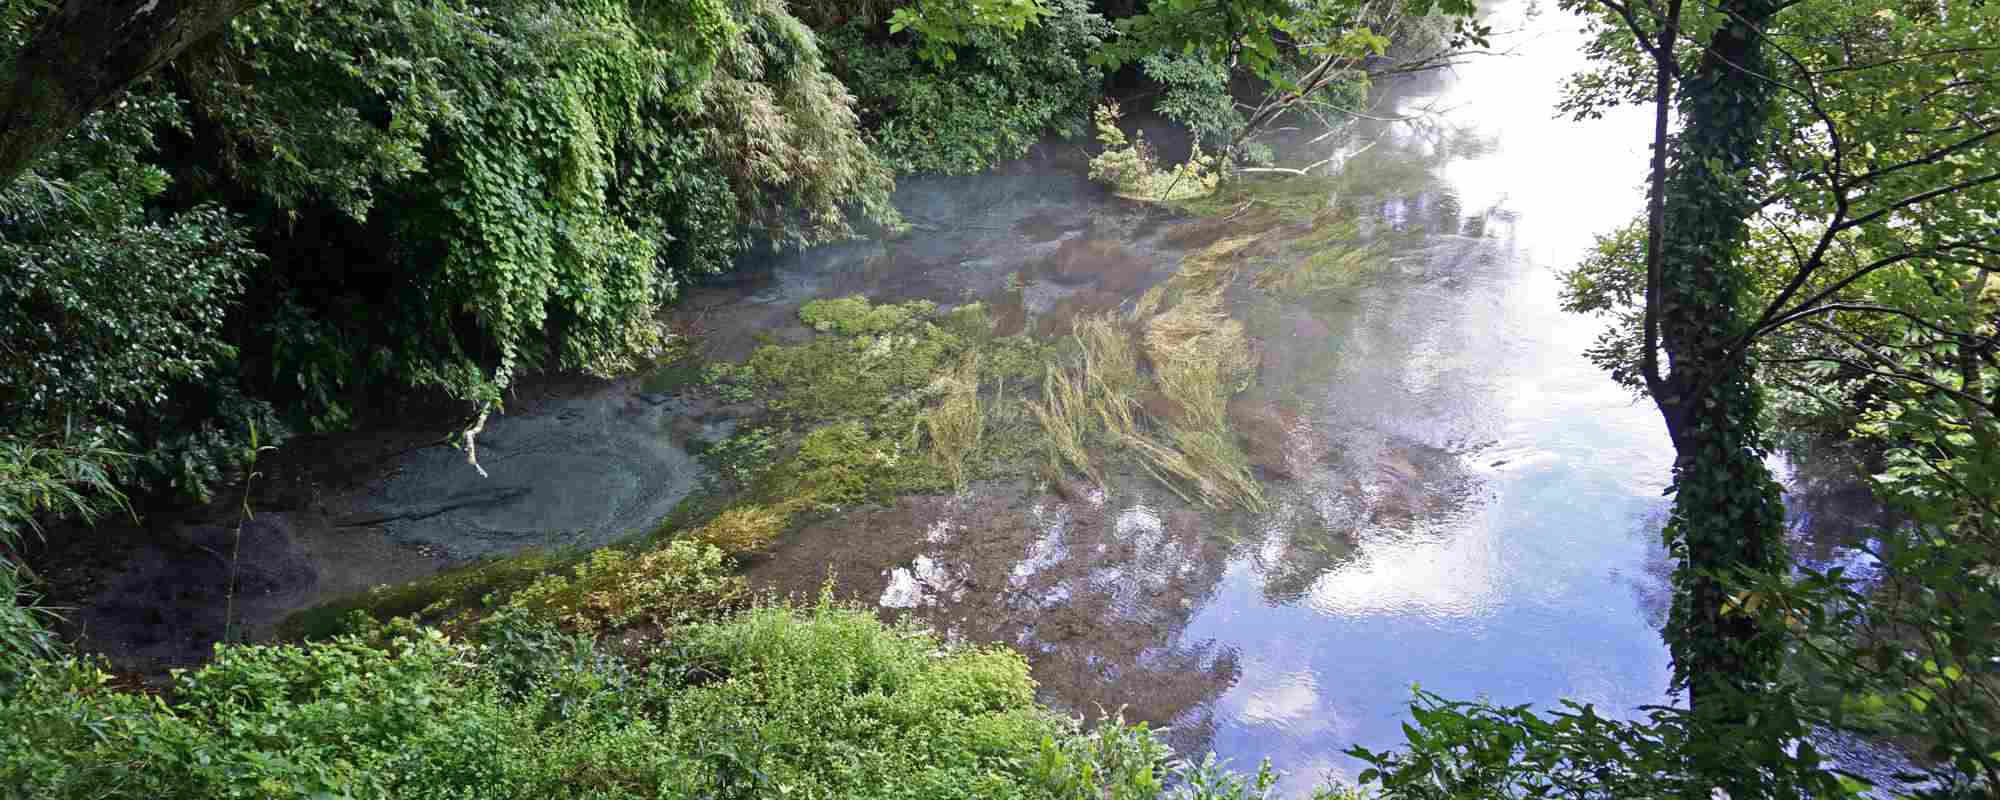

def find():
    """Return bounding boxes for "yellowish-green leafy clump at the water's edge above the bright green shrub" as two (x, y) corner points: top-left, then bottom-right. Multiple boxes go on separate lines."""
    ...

(506, 540), (746, 632)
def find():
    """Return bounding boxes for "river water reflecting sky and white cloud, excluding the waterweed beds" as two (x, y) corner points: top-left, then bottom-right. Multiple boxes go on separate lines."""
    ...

(39, 2), (1896, 794)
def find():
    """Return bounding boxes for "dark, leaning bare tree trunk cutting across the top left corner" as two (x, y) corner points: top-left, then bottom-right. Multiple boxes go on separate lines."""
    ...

(0, 0), (258, 186)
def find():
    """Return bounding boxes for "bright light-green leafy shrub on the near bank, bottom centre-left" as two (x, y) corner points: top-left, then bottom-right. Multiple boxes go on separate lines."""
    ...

(652, 604), (1068, 798)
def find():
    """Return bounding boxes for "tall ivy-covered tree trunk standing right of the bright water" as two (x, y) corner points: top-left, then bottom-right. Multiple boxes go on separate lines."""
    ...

(1654, 0), (1784, 798)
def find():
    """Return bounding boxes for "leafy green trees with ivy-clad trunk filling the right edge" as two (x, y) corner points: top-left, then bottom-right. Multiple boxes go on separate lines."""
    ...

(1528, 2), (2000, 796)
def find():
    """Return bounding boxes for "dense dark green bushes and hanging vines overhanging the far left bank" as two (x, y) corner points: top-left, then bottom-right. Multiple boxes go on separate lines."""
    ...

(0, 0), (896, 500)
